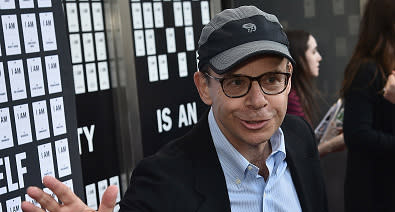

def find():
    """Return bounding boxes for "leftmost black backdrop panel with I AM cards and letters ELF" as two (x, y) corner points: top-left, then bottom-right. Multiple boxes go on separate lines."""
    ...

(0, 0), (84, 211)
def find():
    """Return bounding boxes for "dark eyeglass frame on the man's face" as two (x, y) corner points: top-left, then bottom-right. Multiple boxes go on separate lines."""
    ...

(203, 72), (292, 98)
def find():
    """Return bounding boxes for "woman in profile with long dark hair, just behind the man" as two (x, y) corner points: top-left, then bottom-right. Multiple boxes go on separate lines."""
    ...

(287, 30), (345, 157)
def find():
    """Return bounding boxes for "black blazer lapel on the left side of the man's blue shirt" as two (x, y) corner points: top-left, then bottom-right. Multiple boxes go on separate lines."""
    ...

(185, 113), (230, 212)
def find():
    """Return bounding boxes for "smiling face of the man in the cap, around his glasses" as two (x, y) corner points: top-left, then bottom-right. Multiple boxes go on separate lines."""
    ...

(195, 56), (292, 152)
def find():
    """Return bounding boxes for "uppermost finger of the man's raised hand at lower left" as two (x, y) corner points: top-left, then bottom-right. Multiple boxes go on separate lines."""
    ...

(40, 176), (81, 205)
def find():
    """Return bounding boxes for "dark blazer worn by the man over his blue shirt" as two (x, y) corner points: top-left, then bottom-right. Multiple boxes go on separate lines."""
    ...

(120, 114), (328, 212)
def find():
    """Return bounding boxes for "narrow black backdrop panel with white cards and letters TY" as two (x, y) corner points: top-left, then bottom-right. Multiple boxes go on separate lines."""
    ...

(63, 0), (122, 211)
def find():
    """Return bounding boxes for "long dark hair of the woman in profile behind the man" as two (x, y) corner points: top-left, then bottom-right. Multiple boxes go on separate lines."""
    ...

(286, 30), (320, 123)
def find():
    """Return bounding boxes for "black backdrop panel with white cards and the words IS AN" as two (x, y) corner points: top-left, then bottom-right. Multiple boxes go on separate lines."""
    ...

(131, 1), (209, 156)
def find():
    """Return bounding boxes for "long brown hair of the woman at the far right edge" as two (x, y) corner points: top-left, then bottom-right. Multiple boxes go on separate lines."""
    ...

(340, 0), (395, 97)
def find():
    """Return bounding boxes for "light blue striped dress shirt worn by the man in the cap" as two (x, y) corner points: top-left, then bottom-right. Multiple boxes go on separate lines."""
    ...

(208, 109), (302, 212)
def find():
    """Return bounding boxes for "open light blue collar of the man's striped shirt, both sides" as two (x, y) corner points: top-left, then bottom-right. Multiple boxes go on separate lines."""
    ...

(208, 108), (286, 179)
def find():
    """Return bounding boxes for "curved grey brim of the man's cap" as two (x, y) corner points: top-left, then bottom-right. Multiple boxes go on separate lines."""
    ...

(210, 40), (295, 74)
